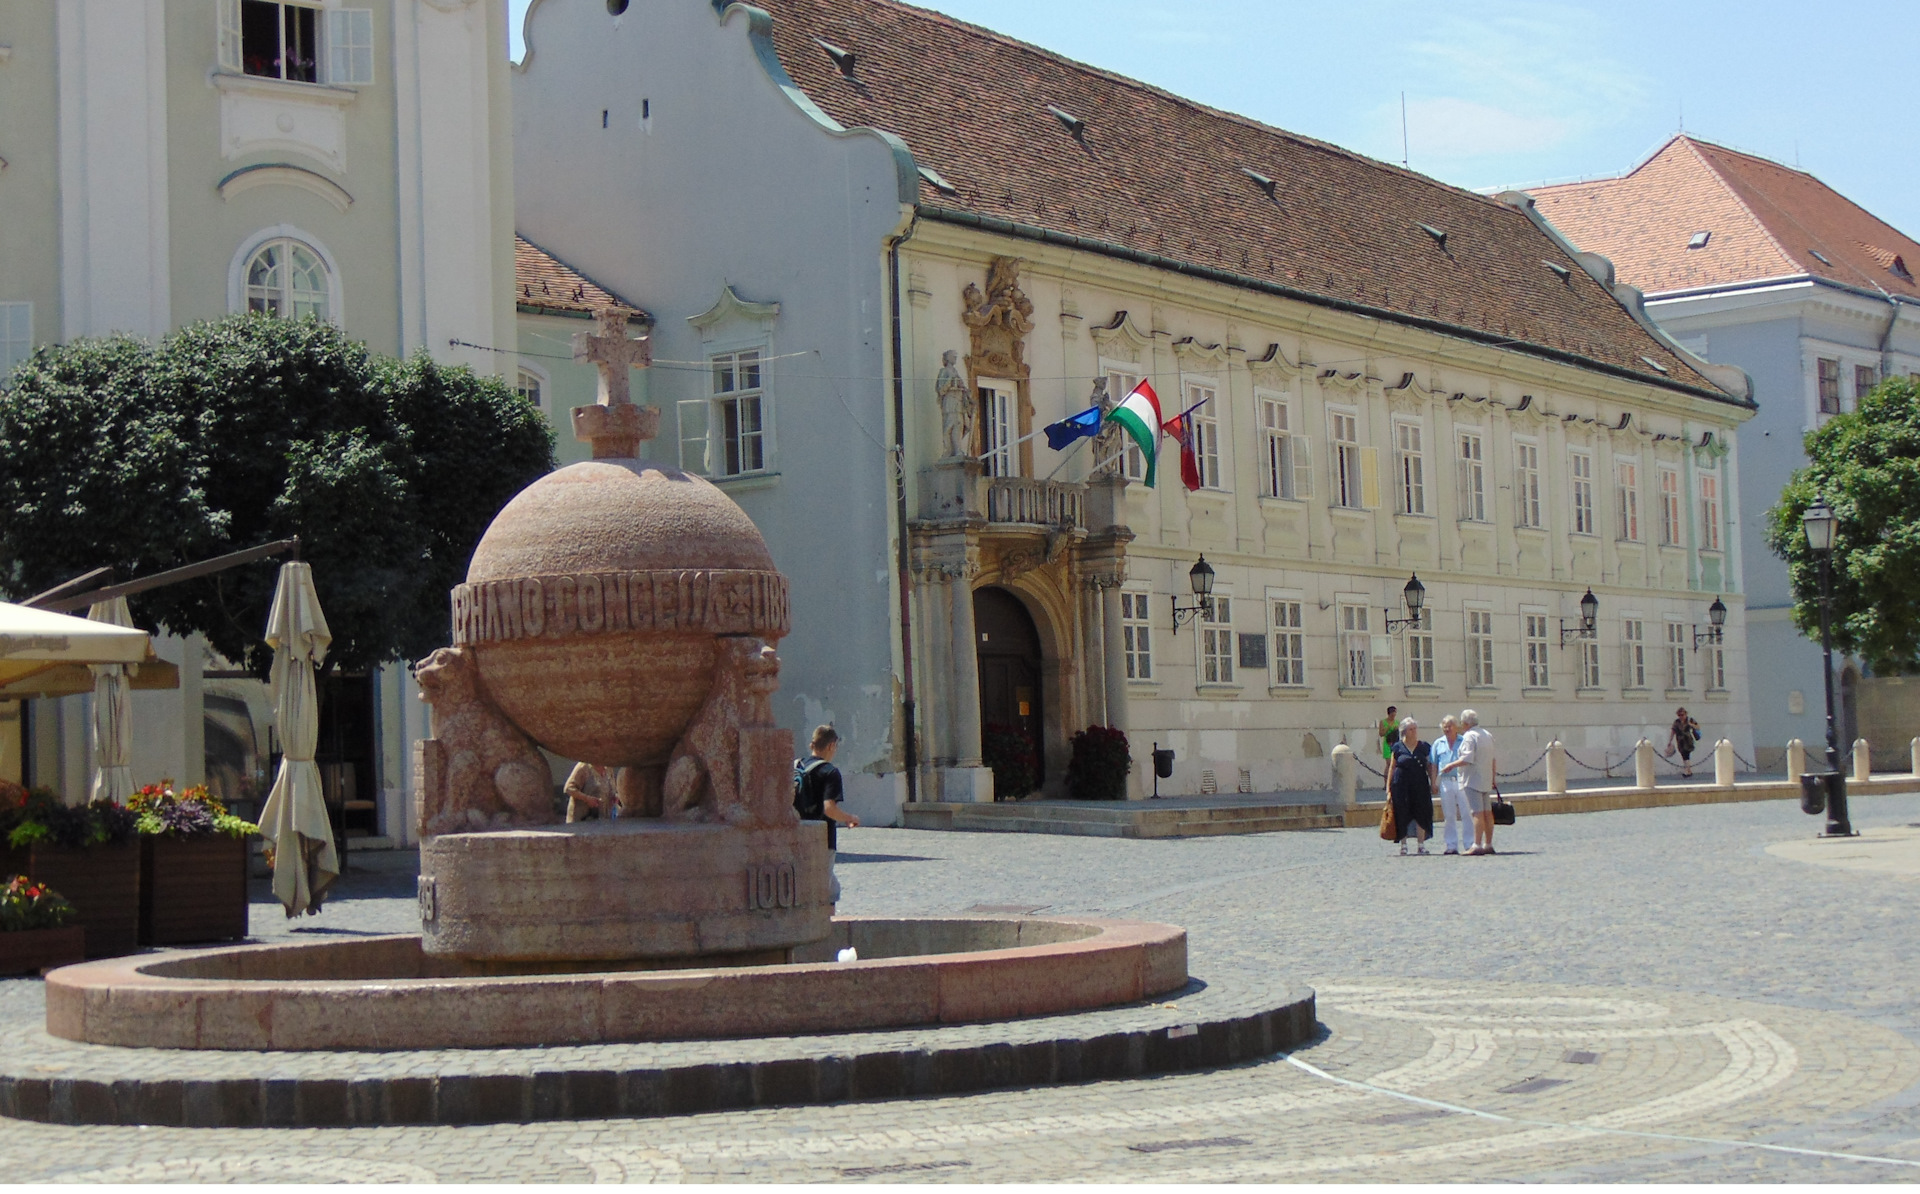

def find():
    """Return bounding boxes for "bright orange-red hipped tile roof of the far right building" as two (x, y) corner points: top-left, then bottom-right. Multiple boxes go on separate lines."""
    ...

(1532, 136), (1920, 299)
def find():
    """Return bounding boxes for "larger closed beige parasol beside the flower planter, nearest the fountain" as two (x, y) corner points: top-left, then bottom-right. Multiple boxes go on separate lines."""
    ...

(259, 561), (340, 916)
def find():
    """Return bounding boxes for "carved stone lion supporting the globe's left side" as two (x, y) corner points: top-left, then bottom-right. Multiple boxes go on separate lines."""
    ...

(413, 647), (553, 837)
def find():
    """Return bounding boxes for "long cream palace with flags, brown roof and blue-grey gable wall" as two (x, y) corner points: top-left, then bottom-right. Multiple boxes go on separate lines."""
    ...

(515, 0), (1753, 822)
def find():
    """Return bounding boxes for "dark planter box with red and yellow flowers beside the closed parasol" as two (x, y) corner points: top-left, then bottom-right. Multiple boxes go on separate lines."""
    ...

(131, 783), (259, 944)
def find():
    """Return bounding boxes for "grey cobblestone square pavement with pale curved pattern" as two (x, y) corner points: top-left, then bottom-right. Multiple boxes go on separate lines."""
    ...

(0, 797), (1920, 1182)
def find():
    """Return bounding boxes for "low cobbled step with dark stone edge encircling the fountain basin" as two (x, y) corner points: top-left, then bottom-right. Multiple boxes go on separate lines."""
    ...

(0, 979), (1319, 1127)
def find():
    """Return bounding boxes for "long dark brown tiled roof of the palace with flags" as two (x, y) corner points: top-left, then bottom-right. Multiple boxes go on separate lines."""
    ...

(756, 0), (1726, 397)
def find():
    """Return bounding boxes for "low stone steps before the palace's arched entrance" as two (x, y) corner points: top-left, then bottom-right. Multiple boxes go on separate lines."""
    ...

(902, 800), (1344, 837)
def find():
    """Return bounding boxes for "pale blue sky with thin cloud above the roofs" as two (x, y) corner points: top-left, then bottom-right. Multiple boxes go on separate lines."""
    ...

(509, 0), (1920, 238)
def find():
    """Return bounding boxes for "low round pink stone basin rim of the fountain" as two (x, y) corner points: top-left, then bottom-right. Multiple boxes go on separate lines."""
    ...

(46, 918), (1187, 1050)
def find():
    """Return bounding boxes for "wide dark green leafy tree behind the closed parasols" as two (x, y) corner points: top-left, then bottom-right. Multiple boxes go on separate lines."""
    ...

(0, 315), (553, 668)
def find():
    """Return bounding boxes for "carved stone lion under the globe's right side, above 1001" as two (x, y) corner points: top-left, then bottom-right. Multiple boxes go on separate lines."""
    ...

(660, 637), (780, 824)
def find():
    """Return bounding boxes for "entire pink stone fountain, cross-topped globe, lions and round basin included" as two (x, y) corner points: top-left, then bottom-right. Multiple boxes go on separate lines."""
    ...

(46, 311), (1188, 1050)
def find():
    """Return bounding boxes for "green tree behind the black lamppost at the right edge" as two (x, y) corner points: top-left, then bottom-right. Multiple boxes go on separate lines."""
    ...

(1766, 378), (1920, 676)
